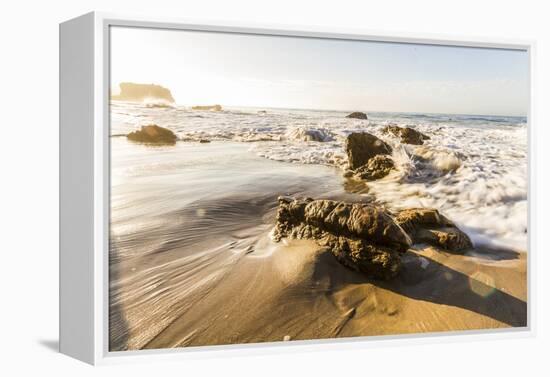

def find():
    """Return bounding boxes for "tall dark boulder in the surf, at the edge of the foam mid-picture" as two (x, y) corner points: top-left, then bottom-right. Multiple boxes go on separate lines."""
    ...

(345, 132), (392, 170)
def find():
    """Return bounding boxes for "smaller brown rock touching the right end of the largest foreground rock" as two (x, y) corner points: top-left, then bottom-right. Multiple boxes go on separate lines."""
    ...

(395, 208), (473, 253)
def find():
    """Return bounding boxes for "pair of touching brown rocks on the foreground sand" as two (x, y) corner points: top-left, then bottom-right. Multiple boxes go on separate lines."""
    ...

(272, 197), (472, 280)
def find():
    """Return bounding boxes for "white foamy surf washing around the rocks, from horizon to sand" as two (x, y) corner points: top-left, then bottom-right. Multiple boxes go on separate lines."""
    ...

(111, 103), (527, 250)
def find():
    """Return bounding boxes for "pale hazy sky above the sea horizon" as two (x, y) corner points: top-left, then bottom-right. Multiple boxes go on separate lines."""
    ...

(111, 27), (529, 115)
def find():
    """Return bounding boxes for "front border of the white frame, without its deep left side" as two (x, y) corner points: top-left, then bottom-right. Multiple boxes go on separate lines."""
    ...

(90, 12), (537, 364)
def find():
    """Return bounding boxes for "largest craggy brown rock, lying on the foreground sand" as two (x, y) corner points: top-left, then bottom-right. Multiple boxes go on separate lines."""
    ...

(272, 197), (411, 280)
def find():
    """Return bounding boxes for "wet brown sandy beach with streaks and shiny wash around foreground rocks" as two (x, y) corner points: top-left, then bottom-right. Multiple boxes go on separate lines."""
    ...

(110, 140), (527, 351)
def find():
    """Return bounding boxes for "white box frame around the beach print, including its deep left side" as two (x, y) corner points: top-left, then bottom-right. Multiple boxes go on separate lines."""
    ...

(60, 12), (537, 364)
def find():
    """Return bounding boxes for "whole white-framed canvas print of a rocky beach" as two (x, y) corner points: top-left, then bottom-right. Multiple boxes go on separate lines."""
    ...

(60, 13), (533, 363)
